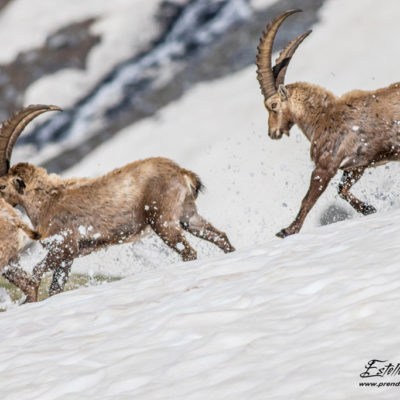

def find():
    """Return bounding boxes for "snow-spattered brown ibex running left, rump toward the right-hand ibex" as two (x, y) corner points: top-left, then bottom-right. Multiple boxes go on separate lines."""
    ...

(0, 105), (234, 301)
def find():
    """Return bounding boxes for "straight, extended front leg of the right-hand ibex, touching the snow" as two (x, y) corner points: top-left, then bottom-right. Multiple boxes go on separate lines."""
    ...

(276, 168), (337, 238)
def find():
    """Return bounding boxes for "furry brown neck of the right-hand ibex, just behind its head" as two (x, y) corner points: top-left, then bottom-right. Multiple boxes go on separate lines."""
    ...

(287, 82), (336, 141)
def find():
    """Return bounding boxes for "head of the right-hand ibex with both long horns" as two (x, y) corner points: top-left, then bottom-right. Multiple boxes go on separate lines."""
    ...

(256, 10), (311, 139)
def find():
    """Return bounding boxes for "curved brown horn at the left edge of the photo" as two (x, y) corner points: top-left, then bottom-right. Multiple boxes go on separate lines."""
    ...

(0, 104), (62, 176)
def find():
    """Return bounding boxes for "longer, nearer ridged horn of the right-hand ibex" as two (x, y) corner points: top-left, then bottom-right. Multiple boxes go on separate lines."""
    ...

(256, 9), (302, 99)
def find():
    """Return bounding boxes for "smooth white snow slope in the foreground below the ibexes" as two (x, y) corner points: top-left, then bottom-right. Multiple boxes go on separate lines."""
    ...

(0, 211), (400, 400)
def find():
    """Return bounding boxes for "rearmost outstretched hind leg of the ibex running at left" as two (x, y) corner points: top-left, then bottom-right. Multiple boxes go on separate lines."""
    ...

(182, 212), (235, 253)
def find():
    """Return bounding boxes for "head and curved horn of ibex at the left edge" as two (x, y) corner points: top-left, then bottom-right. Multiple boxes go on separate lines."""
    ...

(0, 104), (61, 205)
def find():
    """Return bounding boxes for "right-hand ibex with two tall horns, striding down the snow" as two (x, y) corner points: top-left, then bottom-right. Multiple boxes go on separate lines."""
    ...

(256, 10), (400, 238)
